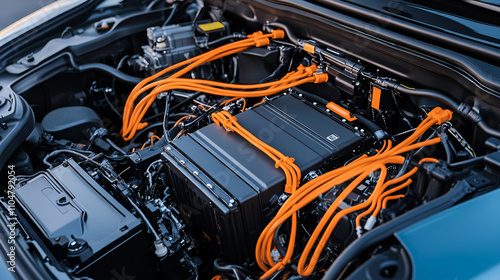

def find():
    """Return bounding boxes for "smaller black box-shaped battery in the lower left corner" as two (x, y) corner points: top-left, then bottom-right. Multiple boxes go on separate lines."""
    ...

(15, 159), (155, 279)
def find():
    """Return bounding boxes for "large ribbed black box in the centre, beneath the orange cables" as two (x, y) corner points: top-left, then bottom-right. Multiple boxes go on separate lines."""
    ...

(162, 95), (364, 263)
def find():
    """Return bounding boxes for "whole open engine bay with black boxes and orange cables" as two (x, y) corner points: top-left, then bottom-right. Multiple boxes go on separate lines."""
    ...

(0, 1), (500, 279)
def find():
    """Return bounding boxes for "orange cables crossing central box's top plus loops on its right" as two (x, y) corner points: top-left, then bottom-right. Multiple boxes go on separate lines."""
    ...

(211, 107), (452, 279)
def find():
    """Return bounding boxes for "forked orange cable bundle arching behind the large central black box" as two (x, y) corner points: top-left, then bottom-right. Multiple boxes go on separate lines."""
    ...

(121, 30), (328, 141)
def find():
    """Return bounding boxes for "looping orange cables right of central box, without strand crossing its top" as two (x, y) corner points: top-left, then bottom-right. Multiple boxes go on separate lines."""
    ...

(255, 107), (452, 279)
